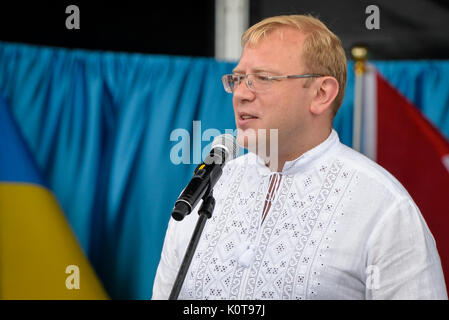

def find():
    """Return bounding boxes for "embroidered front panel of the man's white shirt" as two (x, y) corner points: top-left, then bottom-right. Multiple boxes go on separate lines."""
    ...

(180, 160), (353, 299)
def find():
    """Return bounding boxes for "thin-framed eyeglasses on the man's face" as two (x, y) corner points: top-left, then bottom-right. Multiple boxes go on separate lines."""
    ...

(221, 73), (324, 93)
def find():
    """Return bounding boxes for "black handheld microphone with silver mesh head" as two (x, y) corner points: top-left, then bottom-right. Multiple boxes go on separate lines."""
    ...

(171, 133), (237, 221)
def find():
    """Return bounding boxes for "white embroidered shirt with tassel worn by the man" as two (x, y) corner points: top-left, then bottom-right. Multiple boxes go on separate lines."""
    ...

(153, 130), (447, 300)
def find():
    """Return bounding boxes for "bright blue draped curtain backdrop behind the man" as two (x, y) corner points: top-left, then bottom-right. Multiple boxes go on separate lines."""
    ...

(0, 42), (449, 299)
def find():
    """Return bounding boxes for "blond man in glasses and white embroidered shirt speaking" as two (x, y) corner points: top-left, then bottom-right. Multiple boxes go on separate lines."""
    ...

(153, 15), (447, 299)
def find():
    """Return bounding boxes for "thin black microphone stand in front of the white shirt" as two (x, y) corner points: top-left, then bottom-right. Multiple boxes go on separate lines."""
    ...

(168, 187), (215, 300)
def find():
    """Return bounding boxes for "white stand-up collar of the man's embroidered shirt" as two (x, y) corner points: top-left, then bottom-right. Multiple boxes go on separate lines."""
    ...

(249, 129), (340, 176)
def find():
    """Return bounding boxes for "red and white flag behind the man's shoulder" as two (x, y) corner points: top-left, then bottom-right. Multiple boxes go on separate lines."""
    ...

(355, 64), (449, 288)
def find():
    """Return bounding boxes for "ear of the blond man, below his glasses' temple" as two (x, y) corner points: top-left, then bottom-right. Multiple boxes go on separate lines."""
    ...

(310, 77), (339, 116)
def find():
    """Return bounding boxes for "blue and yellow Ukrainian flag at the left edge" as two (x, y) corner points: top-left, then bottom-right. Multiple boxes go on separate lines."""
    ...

(0, 97), (108, 299)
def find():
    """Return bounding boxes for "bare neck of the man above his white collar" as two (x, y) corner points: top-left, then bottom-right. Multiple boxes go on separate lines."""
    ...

(265, 128), (332, 172)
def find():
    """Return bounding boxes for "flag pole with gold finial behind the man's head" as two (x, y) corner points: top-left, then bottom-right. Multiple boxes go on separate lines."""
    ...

(351, 46), (368, 152)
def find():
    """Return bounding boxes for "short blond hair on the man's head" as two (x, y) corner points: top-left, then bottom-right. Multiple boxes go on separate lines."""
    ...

(242, 15), (347, 117)
